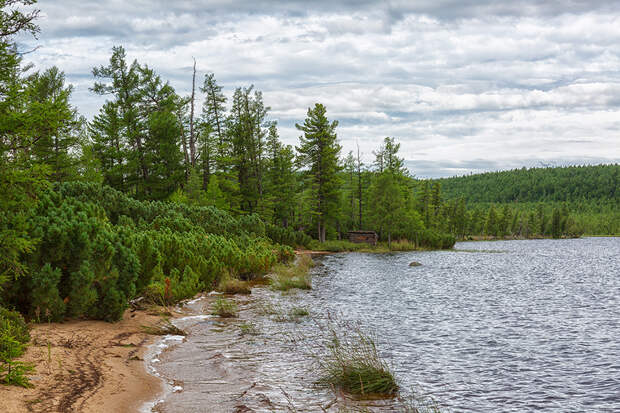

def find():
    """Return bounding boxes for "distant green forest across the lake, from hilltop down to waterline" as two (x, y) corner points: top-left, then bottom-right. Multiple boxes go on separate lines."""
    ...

(433, 164), (620, 238)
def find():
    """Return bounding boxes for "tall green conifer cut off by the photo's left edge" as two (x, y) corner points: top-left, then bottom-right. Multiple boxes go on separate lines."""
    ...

(0, 0), (48, 290)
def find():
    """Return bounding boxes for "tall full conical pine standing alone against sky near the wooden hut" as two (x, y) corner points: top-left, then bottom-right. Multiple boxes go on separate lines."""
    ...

(295, 103), (341, 242)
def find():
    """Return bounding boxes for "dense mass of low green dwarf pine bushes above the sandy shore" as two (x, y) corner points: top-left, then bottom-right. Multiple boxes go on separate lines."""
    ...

(0, 183), (294, 322)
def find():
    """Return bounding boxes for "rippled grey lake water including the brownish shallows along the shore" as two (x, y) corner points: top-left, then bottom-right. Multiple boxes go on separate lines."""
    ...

(153, 238), (620, 413)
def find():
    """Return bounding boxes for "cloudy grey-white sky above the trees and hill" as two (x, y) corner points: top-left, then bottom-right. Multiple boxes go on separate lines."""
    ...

(17, 0), (620, 177)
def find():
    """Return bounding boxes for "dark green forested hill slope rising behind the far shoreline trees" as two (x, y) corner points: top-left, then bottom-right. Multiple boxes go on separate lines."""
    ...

(436, 164), (620, 203)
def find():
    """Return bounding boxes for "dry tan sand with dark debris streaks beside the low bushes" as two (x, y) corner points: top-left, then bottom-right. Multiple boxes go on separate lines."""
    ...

(0, 310), (170, 413)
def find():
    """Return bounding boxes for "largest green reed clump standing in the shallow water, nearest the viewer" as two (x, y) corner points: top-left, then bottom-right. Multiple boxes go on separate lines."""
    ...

(317, 323), (398, 398)
